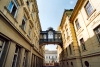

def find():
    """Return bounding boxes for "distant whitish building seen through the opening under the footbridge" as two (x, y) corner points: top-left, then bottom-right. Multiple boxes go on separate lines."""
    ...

(45, 50), (58, 66)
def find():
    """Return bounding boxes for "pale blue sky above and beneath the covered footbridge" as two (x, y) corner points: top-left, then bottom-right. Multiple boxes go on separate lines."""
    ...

(37, 0), (77, 50)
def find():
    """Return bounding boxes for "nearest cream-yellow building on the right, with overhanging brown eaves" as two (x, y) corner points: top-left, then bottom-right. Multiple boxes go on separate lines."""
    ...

(70, 0), (100, 67)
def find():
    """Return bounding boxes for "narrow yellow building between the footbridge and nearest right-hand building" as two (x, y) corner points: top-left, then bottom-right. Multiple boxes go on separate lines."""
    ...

(59, 9), (81, 67)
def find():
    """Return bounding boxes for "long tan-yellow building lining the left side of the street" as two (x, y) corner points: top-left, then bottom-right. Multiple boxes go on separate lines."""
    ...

(0, 0), (44, 67)
